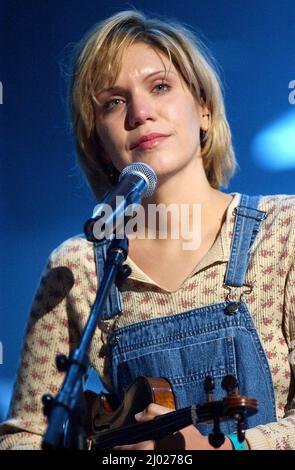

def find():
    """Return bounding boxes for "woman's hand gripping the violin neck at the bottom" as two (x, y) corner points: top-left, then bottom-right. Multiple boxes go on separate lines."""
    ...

(114, 403), (233, 450)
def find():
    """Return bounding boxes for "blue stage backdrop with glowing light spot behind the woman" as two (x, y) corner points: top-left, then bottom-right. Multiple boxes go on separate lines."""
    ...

(0, 0), (295, 419)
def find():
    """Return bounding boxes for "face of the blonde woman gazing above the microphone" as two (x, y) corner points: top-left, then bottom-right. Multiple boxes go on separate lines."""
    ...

(96, 43), (208, 177)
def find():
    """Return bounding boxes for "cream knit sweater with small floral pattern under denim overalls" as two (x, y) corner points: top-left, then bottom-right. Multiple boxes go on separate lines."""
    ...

(0, 193), (295, 450)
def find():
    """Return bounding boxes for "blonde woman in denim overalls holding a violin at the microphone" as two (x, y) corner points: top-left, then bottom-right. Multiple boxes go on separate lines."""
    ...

(1, 11), (295, 450)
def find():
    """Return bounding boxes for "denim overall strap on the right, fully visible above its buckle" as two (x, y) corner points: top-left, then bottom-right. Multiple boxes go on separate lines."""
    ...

(224, 194), (267, 287)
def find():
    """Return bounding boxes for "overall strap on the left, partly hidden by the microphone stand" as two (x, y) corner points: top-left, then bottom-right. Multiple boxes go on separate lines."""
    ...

(94, 240), (123, 320)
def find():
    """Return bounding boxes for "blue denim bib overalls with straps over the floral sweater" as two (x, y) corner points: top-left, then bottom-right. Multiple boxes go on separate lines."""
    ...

(96, 195), (276, 435)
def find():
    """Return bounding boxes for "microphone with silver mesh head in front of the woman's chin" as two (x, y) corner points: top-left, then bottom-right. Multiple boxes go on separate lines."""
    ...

(84, 162), (157, 242)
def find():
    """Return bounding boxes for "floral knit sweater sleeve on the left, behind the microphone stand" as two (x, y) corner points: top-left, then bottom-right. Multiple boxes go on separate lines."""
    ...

(0, 244), (78, 450)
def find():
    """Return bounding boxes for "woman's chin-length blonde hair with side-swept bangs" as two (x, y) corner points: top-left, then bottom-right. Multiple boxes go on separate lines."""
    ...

(69, 11), (236, 197)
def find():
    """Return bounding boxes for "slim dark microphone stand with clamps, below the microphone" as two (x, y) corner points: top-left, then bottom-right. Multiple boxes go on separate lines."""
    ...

(42, 236), (131, 450)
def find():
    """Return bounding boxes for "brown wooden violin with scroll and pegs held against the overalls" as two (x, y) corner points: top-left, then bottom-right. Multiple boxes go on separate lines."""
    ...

(84, 375), (257, 450)
